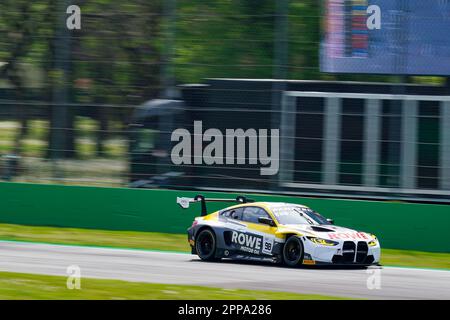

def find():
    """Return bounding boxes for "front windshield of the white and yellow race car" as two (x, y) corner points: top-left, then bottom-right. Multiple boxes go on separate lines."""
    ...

(272, 205), (330, 225)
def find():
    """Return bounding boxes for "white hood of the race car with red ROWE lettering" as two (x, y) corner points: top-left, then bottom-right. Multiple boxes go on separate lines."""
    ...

(279, 224), (375, 241)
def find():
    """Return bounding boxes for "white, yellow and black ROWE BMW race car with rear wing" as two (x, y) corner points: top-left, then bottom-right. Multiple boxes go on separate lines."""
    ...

(177, 195), (380, 267)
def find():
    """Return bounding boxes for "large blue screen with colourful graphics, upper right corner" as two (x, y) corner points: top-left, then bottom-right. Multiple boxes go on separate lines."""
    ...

(321, 0), (450, 75)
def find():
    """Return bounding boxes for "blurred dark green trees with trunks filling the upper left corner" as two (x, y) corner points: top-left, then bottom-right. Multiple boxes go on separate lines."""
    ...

(0, 0), (164, 157)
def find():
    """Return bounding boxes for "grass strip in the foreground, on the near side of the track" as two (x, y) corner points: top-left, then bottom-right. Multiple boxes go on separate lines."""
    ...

(0, 272), (342, 300)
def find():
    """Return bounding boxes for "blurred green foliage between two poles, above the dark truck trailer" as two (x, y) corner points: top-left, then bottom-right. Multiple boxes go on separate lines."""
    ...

(175, 0), (275, 82)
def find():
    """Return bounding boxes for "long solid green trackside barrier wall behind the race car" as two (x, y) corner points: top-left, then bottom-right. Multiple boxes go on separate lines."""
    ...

(0, 183), (450, 252)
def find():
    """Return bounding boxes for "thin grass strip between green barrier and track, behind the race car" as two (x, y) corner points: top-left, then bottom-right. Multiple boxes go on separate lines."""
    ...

(0, 224), (450, 269)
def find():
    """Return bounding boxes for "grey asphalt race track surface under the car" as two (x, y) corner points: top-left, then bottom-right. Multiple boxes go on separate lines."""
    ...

(0, 241), (450, 299)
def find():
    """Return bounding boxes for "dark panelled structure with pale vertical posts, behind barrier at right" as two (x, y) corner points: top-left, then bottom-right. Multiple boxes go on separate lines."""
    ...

(280, 92), (450, 196)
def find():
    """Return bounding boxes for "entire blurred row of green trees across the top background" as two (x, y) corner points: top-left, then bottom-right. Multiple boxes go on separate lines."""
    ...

(0, 0), (398, 162)
